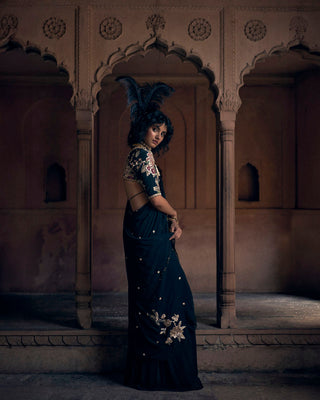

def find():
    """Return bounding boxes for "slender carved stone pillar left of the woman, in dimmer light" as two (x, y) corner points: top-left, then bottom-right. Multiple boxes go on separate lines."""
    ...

(75, 110), (92, 329)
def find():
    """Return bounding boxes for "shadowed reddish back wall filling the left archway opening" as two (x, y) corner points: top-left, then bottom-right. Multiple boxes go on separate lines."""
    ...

(0, 40), (76, 292)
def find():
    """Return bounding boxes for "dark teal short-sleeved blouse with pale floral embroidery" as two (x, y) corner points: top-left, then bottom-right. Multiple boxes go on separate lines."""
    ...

(123, 143), (161, 199)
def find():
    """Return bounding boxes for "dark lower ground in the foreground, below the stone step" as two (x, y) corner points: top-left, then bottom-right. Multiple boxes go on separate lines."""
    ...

(0, 372), (320, 400)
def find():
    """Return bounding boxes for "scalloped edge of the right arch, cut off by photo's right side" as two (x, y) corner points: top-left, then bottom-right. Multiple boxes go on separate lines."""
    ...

(237, 40), (320, 92)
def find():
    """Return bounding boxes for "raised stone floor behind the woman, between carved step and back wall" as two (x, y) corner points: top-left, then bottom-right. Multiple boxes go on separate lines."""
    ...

(0, 293), (320, 331)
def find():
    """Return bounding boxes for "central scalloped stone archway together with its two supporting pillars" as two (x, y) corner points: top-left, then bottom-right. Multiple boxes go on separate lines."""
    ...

(76, 37), (240, 327)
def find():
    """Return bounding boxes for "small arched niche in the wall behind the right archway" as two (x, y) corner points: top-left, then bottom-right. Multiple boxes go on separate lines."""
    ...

(238, 163), (260, 201)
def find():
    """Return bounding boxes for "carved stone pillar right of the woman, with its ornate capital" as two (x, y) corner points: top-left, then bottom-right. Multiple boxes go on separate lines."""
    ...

(217, 92), (240, 328)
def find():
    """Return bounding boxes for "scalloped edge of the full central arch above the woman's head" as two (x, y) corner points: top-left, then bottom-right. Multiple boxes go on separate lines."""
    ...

(91, 37), (219, 112)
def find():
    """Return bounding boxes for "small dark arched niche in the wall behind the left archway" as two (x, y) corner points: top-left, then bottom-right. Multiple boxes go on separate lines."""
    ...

(45, 163), (67, 203)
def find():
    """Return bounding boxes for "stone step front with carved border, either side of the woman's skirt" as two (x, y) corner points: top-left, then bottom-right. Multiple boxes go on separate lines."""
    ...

(0, 329), (320, 373)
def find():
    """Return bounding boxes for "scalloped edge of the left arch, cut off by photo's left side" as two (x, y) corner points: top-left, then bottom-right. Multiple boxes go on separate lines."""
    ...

(0, 37), (74, 91)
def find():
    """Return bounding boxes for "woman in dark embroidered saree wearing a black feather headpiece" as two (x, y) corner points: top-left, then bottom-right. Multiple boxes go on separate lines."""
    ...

(117, 77), (202, 391)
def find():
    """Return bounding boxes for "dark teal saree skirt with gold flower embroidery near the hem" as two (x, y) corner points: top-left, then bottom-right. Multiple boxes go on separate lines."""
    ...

(123, 203), (202, 391)
